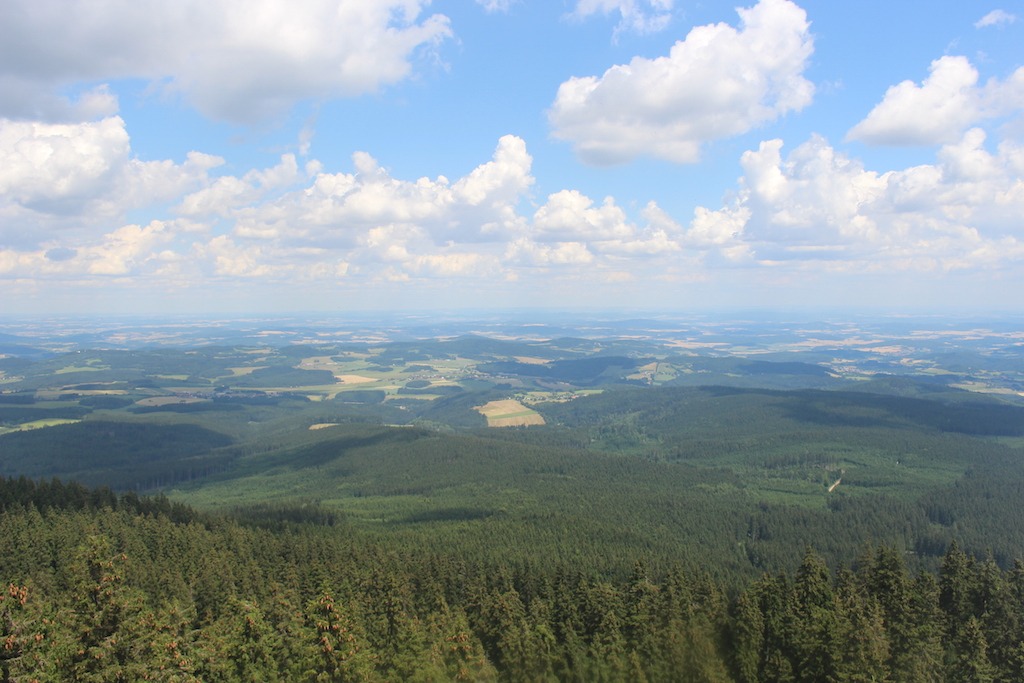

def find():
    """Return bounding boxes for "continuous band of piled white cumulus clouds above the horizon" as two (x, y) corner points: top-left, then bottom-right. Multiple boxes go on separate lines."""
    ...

(0, 112), (1024, 305)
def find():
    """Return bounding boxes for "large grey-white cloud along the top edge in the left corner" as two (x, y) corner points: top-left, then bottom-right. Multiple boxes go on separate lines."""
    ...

(0, 0), (452, 122)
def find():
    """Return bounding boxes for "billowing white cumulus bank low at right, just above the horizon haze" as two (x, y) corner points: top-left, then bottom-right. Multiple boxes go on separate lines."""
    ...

(700, 129), (1024, 271)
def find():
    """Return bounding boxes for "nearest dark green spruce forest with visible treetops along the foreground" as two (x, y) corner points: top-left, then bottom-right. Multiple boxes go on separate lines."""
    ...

(0, 478), (1024, 682)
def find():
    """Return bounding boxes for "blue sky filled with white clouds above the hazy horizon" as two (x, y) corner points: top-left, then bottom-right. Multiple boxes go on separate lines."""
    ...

(0, 0), (1024, 316)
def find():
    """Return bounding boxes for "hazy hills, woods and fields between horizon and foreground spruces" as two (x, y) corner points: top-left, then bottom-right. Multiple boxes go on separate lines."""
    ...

(0, 316), (1024, 557)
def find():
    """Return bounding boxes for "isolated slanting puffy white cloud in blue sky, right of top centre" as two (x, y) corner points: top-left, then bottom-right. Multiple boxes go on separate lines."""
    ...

(548, 0), (814, 164)
